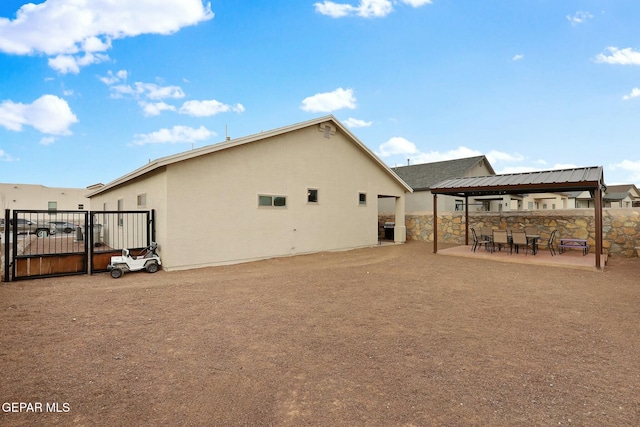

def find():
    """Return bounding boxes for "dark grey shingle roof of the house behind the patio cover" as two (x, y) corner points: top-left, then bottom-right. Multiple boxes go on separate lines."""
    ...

(392, 156), (496, 191)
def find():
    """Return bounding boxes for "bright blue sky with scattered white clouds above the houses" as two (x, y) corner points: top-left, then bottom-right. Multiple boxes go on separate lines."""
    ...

(0, 0), (640, 187)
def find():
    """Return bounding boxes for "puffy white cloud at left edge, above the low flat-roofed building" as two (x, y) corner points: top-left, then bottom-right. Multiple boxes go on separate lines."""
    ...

(0, 95), (78, 135)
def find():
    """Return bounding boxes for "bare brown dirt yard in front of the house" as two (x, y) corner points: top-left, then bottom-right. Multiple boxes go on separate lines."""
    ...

(0, 242), (640, 426)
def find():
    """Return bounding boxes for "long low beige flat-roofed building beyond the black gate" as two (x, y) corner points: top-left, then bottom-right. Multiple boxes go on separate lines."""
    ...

(0, 183), (90, 211)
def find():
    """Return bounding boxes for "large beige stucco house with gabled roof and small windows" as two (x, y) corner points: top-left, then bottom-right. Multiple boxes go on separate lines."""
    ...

(88, 116), (412, 270)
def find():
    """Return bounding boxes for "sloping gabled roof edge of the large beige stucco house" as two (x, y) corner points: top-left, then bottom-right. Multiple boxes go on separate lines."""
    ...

(87, 115), (413, 198)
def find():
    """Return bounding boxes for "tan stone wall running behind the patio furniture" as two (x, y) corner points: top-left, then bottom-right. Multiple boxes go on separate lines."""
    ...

(378, 208), (640, 257)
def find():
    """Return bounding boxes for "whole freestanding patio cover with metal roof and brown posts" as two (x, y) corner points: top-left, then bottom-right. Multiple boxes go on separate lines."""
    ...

(431, 166), (607, 268)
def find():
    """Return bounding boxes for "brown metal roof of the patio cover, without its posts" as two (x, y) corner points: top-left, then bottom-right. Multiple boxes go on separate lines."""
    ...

(431, 166), (606, 195)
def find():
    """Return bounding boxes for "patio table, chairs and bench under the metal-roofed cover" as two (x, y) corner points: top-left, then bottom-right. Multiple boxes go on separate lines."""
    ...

(471, 227), (589, 256)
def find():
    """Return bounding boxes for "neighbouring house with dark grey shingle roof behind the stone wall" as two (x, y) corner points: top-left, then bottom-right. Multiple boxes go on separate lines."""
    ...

(380, 156), (496, 214)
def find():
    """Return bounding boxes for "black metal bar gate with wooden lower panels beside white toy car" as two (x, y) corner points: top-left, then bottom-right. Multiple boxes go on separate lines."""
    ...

(0, 210), (155, 282)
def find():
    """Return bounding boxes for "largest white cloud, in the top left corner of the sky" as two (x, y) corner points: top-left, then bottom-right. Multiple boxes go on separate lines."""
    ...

(0, 0), (214, 73)
